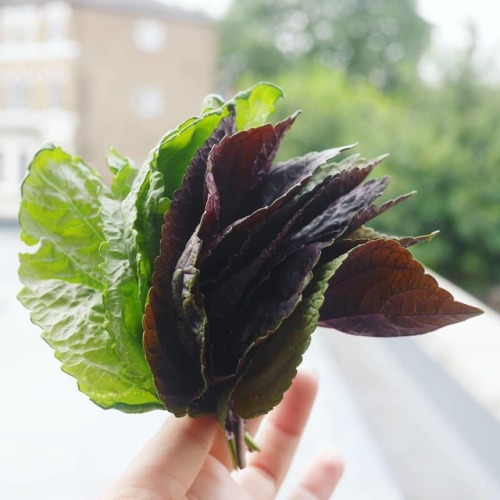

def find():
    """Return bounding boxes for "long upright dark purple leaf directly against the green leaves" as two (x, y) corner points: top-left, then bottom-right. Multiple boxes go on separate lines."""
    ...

(143, 115), (234, 415)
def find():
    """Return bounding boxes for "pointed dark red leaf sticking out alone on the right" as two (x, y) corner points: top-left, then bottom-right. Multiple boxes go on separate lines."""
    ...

(320, 240), (482, 337)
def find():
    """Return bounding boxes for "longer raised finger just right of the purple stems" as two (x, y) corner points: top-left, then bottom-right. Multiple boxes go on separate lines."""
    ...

(238, 372), (318, 499)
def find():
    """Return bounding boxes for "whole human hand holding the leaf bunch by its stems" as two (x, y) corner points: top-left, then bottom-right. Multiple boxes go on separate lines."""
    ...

(100, 372), (343, 500)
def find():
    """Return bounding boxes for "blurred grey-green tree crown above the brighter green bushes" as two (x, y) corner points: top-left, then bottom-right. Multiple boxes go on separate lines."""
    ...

(220, 0), (430, 88)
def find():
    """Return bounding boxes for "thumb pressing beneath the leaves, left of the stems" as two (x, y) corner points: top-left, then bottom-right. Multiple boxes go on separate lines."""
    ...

(100, 417), (218, 500)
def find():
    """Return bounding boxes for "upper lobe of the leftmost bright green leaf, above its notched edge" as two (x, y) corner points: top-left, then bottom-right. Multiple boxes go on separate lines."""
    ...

(19, 147), (104, 290)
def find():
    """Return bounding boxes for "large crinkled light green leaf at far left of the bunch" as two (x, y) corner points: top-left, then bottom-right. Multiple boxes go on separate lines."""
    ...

(19, 148), (160, 411)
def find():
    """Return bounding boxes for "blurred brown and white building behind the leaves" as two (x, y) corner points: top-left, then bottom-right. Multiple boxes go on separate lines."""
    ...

(0, 0), (216, 218)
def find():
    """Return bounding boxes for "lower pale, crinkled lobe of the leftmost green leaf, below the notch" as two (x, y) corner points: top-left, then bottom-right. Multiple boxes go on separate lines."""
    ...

(19, 280), (159, 412)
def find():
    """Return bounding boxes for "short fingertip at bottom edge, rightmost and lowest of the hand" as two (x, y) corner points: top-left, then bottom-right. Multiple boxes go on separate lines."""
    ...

(290, 452), (344, 500)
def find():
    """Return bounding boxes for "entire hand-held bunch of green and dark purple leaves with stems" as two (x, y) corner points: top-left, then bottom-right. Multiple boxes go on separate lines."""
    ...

(19, 84), (480, 466)
